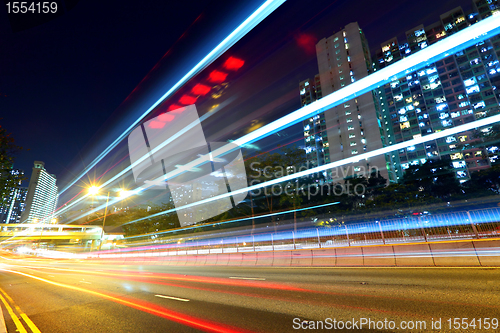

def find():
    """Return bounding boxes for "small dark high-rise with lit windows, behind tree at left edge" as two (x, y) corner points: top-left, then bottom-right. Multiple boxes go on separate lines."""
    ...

(0, 169), (28, 223)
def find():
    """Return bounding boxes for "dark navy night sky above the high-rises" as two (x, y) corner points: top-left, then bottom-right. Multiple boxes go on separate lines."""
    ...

(0, 0), (471, 195)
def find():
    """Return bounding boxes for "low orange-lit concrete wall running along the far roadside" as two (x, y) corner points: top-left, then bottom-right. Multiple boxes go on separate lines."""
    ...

(88, 239), (500, 267)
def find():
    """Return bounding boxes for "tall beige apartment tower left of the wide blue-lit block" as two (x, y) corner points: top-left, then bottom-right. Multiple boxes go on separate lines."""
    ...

(299, 23), (392, 181)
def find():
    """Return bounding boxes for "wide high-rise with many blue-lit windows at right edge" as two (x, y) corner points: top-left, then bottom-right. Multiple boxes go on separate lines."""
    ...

(375, 0), (500, 182)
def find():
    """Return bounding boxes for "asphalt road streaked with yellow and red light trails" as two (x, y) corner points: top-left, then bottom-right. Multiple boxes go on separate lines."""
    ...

(0, 254), (500, 333)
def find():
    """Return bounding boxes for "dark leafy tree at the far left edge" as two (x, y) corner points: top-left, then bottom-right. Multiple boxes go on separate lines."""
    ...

(0, 125), (24, 201)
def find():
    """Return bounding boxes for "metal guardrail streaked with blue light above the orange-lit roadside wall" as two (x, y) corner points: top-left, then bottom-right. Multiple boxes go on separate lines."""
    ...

(96, 208), (500, 255)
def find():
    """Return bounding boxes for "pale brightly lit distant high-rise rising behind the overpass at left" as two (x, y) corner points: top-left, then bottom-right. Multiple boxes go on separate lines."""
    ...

(21, 161), (58, 223)
